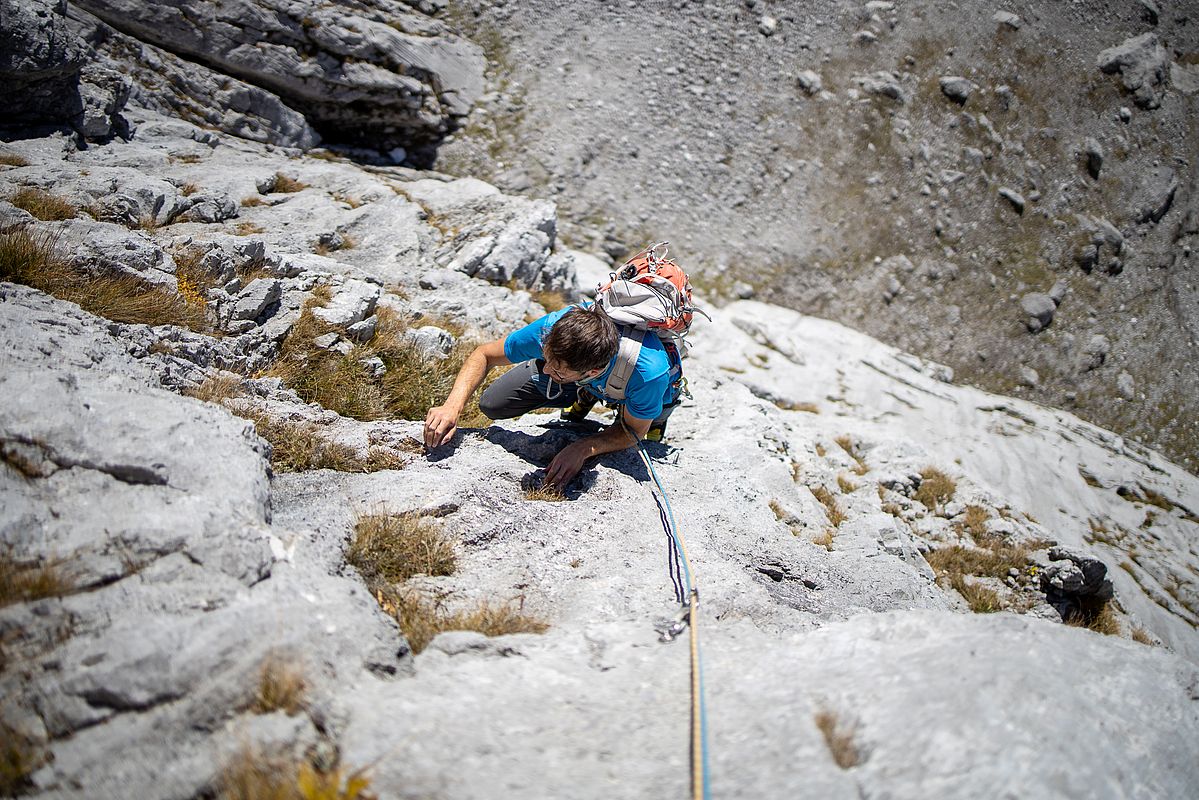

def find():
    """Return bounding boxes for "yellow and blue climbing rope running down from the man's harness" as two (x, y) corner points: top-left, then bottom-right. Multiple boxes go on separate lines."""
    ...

(621, 434), (711, 800)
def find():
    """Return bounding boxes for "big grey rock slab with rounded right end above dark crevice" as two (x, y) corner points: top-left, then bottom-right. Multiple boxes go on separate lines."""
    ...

(78, 0), (483, 157)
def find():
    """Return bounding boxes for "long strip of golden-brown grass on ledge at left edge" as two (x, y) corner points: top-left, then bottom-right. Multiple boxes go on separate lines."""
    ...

(0, 230), (207, 331)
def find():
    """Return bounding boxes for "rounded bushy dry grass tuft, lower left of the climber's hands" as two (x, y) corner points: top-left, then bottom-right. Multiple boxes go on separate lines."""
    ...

(345, 513), (458, 585)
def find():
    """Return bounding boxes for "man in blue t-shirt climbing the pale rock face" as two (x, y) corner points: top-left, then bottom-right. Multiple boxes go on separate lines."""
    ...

(424, 303), (681, 489)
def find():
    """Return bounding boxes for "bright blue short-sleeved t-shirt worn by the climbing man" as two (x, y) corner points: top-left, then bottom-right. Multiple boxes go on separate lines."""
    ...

(504, 306), (671, 420)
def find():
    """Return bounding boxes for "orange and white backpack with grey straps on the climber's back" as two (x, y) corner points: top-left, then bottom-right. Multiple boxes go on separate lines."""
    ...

(596, 242), (711, 402)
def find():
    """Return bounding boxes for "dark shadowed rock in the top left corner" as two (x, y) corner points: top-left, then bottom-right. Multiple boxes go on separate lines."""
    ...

(0, 0), (85, 124)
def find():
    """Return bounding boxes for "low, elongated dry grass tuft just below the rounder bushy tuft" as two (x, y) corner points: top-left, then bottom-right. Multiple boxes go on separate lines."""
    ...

(375, 588), (549, 652)
